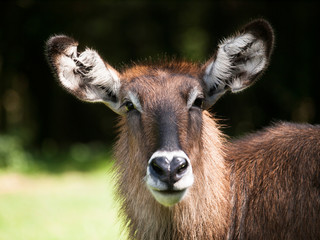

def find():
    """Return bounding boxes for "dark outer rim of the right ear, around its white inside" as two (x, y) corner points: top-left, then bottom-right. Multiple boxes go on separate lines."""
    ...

(202, 18), (275, 109)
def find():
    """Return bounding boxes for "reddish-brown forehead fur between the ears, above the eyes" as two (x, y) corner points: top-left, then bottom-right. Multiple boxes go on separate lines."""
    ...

(120, 61), (203, 109)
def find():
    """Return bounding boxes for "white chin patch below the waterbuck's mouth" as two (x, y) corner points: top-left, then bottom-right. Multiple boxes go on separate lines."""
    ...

(150, 189), (188, 207)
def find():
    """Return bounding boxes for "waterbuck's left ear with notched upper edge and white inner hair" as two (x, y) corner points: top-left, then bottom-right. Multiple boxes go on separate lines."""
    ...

(46, 35), (121, 114)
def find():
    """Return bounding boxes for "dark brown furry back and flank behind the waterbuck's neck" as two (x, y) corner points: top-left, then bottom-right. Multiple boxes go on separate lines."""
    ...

(227, 123), (320, 239)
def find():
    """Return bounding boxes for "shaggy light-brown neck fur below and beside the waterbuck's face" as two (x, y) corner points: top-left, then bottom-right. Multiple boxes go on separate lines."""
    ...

(115, 109), (231, 240)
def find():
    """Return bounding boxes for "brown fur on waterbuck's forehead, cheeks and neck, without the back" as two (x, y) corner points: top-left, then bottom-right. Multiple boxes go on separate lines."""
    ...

(110, 62), (230, 240)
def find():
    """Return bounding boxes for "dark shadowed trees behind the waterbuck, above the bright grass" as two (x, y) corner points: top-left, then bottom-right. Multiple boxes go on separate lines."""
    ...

(0, 0), (320, 156)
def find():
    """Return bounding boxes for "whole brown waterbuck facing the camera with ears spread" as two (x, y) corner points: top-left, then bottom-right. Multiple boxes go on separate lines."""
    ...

(46, 19), (320, 240)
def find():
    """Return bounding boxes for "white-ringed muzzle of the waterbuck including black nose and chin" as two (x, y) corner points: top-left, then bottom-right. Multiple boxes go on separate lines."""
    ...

(146, 150), (194, 206)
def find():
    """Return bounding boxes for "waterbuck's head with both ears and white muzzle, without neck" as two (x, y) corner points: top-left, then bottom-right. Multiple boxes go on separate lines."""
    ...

(47, 20), (273, 206)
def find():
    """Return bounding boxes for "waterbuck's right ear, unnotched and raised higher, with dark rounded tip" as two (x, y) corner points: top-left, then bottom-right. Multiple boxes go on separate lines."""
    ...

(203, 19), (274, 107)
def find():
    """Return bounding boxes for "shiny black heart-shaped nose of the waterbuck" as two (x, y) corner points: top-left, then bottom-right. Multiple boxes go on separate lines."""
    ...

(150, 157), (189, 186)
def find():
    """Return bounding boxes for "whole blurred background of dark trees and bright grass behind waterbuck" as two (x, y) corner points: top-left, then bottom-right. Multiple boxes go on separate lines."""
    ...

(0, 0), (320, 240)
